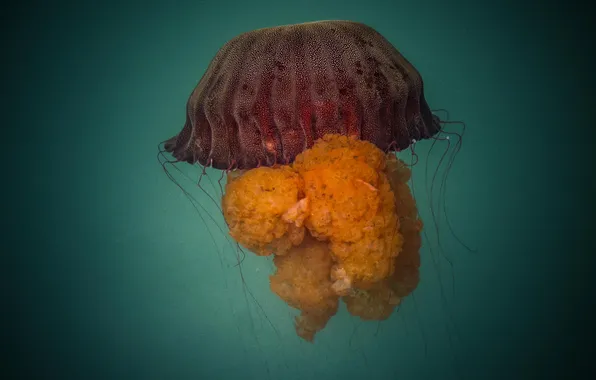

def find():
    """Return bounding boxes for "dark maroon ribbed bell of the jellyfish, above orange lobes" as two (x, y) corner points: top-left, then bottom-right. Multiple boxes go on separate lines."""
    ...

(165, 21), (440, 169)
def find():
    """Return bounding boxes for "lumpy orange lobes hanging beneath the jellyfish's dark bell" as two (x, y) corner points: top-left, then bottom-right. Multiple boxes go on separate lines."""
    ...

(222, 135), (422, 341)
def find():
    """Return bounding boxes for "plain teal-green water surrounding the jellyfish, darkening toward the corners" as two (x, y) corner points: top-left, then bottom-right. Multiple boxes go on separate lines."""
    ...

(0, 0), (596, 380)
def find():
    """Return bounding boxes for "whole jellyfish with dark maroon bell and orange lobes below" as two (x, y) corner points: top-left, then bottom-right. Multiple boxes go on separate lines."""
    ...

(164, 21), (464, 342)
